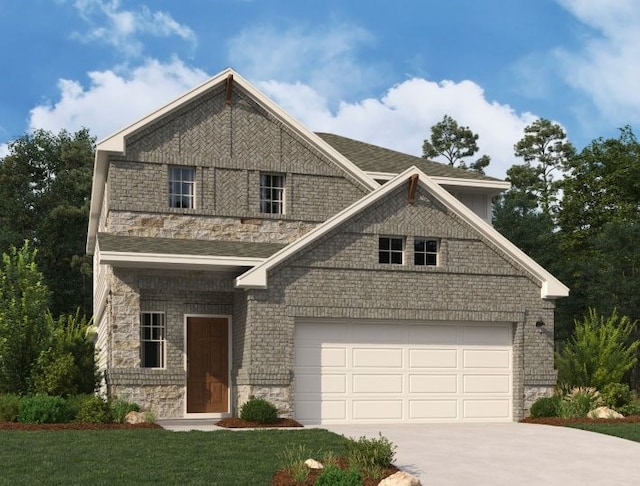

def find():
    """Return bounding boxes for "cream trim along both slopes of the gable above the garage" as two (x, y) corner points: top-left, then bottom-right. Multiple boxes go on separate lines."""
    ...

(236, 167), (569, 299)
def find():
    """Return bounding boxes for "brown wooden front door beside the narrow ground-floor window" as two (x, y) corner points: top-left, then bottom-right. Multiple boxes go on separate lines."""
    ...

(187, 317), (229, 413)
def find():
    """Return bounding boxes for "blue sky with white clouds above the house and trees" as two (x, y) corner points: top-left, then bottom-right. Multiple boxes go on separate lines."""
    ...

(0, 0), (640, 178)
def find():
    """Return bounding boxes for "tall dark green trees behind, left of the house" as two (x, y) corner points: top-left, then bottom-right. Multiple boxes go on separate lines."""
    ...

(0, 129), (95, 315)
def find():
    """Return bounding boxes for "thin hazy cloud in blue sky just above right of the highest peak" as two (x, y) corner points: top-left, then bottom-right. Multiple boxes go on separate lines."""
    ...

(228, 21), (381, 102)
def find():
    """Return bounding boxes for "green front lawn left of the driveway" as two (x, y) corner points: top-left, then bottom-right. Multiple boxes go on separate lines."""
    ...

(0, 429), (346, 486)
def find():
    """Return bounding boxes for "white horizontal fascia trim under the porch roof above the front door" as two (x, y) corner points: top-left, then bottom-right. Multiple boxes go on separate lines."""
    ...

(100, 251), (266, 268)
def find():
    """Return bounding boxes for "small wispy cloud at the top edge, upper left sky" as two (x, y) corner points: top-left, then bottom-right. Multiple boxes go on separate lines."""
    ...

(73, 0), (196, 56)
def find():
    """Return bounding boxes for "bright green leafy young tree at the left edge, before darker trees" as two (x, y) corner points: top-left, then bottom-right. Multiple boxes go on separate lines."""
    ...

(0, 242), (49, 394)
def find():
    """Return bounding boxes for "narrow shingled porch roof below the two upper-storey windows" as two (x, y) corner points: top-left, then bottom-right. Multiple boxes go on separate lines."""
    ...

(98, 233), (286, 258)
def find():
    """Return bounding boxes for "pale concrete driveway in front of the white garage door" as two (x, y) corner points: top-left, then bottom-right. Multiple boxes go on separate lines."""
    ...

(321, 423), (640, 486)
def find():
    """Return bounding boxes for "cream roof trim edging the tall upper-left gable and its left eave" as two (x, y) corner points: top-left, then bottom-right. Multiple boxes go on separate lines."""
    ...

(86, 68), (379, 254)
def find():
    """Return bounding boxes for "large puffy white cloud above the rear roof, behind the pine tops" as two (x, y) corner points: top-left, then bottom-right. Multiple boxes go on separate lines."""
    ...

(259, 78), (537, 177)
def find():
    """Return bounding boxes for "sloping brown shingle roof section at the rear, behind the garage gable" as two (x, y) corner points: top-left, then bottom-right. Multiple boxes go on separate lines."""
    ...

(316, 133), (500, 181)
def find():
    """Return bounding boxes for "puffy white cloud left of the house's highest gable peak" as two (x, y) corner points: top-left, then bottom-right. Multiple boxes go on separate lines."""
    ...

(29, 59), (207, 139)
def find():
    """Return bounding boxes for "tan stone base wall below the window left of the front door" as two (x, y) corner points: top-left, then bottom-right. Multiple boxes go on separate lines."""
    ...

(108, 385), (185, 419)
